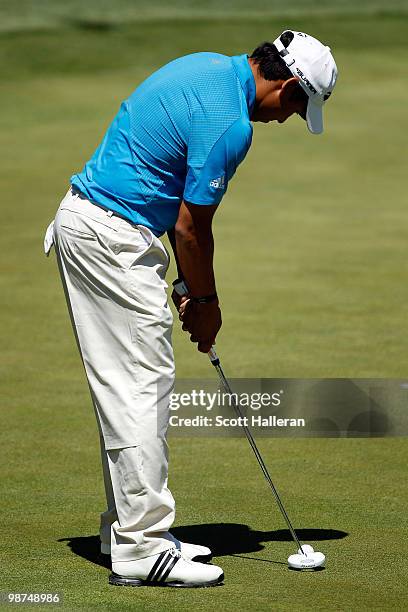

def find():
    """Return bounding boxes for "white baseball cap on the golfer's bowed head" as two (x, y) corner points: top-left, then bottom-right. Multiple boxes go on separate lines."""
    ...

(273, 30), (337, 134)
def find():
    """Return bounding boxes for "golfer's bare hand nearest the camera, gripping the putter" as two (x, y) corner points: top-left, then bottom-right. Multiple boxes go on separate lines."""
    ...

(179, 299), (222, 353)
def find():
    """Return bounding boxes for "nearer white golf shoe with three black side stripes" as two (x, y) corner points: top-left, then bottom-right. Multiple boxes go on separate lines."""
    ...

(109, 548), (224, 588)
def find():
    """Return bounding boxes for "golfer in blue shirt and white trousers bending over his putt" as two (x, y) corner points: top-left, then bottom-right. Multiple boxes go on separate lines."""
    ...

(45, 31), (337, 587)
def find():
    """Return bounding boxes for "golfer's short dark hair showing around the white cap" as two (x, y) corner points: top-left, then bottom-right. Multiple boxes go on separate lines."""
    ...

(249, 31), (308, 110)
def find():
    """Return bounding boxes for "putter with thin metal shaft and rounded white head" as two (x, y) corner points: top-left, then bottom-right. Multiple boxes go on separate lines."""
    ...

(208, 347), (326, 570)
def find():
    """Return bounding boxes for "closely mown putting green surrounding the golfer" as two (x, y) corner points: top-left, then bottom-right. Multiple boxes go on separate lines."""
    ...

(0, 2), (408, 611)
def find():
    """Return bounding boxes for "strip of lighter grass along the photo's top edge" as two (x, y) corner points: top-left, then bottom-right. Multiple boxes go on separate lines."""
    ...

(0, 0), (407, 32)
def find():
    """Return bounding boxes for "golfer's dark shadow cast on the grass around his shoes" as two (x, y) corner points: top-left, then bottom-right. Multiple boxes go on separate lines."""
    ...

(58, 523), (348, 568)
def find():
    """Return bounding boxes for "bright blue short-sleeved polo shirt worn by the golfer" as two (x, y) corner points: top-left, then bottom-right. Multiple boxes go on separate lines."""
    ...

(71, 53), (256, 236)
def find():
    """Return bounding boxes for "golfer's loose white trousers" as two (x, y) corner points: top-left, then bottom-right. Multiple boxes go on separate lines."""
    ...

(49, 190), (175, 561)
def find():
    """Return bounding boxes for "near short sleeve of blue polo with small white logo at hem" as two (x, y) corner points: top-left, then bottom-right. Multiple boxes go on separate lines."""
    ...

(183, 118), (252, 205)
